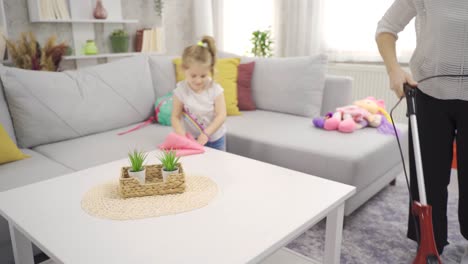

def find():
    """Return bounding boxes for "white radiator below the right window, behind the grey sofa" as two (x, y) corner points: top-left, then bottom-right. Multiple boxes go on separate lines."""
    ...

(328, 63), (408, 123)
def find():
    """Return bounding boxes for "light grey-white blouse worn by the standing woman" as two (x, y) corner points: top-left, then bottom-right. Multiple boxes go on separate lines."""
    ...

(376, 0), (468, 101)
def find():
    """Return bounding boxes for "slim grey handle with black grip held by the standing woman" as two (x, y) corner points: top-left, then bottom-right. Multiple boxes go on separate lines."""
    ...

(403, 83), (427, 205)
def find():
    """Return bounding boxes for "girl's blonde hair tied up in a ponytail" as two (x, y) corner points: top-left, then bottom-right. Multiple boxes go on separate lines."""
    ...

(182, 36), (216, 76)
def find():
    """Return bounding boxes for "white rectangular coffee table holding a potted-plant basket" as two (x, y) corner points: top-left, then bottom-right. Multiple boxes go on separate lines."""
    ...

(0, 149), (355, 264)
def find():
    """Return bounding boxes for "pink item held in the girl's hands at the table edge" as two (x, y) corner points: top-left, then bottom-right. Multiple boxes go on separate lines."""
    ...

(158, 132), (205, 157)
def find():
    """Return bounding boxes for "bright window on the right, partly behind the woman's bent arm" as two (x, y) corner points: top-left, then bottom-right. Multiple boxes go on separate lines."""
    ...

(323, 0), (416, 62)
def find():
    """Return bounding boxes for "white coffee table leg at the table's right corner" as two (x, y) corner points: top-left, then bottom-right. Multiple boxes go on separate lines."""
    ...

(323, 204), (344, 264)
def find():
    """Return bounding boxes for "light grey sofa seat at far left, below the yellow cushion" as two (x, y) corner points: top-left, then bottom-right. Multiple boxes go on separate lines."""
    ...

(0, 149), (73, 192)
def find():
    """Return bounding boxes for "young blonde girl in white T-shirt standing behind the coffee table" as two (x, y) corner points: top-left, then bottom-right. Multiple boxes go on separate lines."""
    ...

(171, 36), (226, 151)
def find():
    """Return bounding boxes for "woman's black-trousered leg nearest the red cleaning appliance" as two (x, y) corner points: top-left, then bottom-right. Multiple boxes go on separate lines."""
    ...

(407, 90), (455, 254)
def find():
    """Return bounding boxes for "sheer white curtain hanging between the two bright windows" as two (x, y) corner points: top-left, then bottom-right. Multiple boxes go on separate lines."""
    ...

(273, 0), (324, 57)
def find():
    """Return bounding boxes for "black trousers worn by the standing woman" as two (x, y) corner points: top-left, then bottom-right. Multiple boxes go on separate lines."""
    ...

(407, 90), (468, 254)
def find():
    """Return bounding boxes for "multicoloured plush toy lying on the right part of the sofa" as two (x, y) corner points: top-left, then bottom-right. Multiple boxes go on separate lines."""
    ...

(313, 96), (395, 135)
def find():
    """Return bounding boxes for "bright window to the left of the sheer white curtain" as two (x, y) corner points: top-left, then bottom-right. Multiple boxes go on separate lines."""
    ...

(221, 0), (274, 55)
